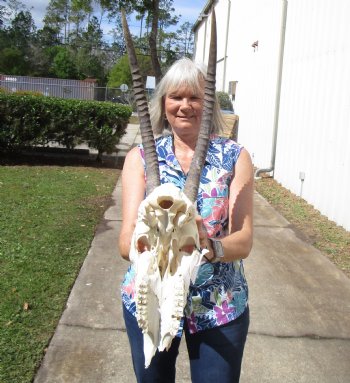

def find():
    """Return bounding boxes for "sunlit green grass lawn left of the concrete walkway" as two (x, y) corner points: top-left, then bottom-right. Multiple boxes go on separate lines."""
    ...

(0, 166), (120, 383)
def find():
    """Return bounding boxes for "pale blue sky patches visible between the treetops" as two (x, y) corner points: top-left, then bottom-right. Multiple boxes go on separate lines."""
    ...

(27, 0), (207, 39)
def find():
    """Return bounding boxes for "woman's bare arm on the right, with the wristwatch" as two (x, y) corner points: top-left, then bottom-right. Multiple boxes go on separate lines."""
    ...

(204, 149), (254, 262)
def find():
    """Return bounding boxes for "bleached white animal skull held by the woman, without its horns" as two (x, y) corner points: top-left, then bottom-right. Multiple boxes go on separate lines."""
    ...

(130, 184), (206, 367)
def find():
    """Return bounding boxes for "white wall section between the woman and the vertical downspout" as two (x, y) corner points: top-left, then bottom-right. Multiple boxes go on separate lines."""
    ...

(228, 0), (281, 167)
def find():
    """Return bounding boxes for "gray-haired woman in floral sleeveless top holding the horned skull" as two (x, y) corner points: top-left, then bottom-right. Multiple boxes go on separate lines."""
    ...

(119, 59), (253, 383)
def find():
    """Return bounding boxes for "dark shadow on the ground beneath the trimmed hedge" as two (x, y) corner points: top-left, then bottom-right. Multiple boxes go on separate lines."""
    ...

(0, 148), (125, 169)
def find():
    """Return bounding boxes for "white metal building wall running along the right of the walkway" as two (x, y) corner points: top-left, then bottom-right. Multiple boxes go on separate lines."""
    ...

(195, 0), (350, 230)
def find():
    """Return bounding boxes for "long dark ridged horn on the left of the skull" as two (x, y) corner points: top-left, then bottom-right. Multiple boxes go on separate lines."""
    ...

(121, 9), (160, 194)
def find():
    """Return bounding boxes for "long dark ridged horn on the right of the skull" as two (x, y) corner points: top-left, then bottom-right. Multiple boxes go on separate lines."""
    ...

(184, 7), (217, 202)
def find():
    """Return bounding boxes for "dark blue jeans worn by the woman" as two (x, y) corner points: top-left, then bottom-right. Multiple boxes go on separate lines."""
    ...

(123, 305), (249, 383)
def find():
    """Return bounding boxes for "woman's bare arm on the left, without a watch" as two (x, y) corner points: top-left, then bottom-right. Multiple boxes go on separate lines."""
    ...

(119, 147), (146, 260)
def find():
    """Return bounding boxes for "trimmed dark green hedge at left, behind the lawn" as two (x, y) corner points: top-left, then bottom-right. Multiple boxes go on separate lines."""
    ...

(0, 93), (132, 159)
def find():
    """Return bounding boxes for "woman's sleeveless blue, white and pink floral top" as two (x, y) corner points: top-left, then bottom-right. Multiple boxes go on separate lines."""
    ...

(121, 135), (248, 333)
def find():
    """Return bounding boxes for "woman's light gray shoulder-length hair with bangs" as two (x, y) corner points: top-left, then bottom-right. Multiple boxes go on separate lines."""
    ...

(150, 58), (224, 136)
